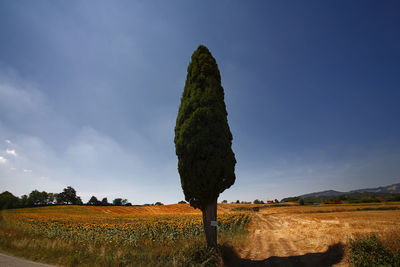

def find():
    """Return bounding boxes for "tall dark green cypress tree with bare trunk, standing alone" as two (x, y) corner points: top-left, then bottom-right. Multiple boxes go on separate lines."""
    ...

(174, 45), (236, 246)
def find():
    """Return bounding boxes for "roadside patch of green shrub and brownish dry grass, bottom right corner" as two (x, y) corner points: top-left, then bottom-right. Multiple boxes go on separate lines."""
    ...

(348, 233), (400, 267)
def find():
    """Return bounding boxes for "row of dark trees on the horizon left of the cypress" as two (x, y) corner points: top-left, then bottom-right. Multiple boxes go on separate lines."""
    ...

(0, 186), (132, 209)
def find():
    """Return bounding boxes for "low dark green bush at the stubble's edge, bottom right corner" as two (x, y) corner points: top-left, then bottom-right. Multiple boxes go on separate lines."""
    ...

(349, 234), (400, 267)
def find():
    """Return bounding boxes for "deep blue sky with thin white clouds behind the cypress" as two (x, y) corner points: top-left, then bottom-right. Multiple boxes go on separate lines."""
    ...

(0, 1), (400, 204)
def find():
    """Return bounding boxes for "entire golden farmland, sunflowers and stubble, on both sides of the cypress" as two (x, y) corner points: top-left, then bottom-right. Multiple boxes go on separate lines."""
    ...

(0, 202), (400, 266)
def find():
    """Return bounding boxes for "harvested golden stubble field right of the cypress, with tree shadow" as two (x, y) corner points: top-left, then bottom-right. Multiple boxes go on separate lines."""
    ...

(225, 203), (400, 266)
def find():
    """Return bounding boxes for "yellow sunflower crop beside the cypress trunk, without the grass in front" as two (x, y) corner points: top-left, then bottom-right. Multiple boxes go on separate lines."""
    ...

(4, 205), (250, 246)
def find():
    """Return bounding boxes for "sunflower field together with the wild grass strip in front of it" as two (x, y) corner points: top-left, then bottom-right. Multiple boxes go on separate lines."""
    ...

(0, 204), (251, 266)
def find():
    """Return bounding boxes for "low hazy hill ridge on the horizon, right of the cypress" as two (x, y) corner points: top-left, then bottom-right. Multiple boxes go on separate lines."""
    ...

(282, 183), (400, 202)
